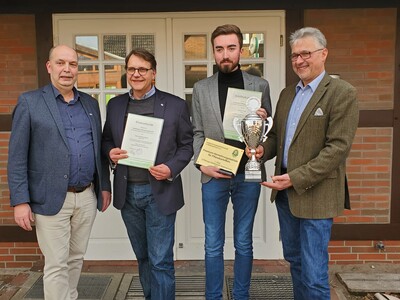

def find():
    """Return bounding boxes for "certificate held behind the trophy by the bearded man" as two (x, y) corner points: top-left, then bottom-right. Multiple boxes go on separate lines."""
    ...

(222, 88), (262, 141)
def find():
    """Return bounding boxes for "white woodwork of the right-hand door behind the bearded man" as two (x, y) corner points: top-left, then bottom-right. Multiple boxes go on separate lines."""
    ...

(172, 11), (285, 259)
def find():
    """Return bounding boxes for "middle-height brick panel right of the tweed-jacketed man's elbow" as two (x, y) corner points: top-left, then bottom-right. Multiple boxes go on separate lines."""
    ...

(335, 128), (393, 223)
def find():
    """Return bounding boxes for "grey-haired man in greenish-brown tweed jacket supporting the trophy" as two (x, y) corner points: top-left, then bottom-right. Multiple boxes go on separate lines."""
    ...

(252, 27), (358, 300)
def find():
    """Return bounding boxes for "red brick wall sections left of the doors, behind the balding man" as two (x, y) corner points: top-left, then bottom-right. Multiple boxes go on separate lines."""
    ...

(0, 15), (41, 268)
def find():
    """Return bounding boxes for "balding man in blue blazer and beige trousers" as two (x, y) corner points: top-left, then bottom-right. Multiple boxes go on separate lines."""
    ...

(8, 45), (111, 300)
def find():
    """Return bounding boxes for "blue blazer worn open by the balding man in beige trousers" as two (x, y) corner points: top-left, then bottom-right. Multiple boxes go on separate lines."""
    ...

(7, 84), (111, 215)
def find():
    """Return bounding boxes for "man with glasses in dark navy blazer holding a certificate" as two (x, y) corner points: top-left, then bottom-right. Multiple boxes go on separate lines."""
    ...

(102, 49), (193, 300)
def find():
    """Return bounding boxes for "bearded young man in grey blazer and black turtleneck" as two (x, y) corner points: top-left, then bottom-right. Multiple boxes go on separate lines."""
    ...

(192, 24), (271, 299)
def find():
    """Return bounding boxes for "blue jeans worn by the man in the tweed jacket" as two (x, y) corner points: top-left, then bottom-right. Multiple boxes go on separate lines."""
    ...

(275, 190), (333, 300)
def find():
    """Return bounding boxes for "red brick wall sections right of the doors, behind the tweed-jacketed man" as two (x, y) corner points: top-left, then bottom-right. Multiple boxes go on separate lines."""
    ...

(304, 8), (400, 264)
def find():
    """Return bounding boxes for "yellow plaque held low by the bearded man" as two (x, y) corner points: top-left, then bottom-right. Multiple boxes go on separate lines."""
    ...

(196, 138), (244, 174)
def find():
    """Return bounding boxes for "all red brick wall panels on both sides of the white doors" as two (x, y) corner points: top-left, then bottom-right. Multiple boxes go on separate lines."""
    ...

(0, 8), (400, 268)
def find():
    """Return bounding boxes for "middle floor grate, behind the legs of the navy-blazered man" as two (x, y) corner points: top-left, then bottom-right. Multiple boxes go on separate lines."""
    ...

(125, 275), (205, 300)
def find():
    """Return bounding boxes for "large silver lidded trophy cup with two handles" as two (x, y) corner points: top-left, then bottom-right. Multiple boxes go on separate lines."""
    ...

(233, 97), (273, 182)
